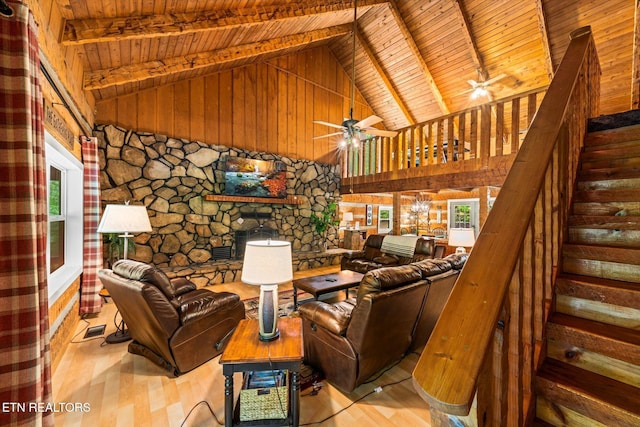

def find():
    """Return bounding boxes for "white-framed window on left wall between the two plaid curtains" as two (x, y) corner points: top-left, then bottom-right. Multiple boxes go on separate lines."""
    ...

(45, 132), (83, 304)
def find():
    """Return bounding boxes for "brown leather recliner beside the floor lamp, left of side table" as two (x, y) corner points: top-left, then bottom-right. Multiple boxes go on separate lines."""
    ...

(98, 260), (245, 376)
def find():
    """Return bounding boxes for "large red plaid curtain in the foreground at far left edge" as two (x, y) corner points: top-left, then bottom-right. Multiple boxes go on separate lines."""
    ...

(0, 2), (53, 426)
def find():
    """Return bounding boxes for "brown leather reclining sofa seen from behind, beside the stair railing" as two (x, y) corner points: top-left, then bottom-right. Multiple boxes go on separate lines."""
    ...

(299, 254), (467, 392)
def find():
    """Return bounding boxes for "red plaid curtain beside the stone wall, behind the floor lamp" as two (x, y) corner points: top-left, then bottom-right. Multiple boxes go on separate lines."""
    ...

(80, 136), (102, 314)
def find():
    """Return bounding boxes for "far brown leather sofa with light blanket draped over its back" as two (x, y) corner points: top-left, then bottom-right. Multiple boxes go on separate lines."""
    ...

(340, 234), (445, 274)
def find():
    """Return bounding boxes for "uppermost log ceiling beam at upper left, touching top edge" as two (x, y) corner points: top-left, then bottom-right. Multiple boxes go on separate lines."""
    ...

(58, 0), (388, 45)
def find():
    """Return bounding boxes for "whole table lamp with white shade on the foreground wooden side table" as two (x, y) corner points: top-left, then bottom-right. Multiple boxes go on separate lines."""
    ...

(241, 239), (293, 341)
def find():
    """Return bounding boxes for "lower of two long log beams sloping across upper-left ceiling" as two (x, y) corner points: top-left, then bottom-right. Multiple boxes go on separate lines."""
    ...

(84, 24), (351, 90)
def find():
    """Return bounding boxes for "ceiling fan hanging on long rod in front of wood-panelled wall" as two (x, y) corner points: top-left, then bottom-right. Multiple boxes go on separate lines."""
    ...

(313, 1), (398, 146)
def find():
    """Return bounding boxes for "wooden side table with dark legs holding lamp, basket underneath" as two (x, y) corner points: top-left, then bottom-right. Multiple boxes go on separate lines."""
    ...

(220, 317), (304, 427)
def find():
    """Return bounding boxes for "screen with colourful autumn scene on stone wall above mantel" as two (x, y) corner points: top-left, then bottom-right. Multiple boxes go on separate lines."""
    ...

(225, 157), (287, 198)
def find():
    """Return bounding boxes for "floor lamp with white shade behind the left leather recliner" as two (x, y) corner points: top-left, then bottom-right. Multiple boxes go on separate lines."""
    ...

(98, 202), (152, 344)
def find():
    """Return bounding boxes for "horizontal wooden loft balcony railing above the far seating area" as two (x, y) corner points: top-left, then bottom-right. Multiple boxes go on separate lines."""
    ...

(342, 88), (546, 184)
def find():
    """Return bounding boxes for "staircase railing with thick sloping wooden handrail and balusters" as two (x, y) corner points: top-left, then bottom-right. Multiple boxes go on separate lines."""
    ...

(413, 27), (600, 426)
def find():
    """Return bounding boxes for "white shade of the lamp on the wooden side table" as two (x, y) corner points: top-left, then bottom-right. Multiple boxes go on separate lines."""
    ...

(241, 240), (293, 285)
